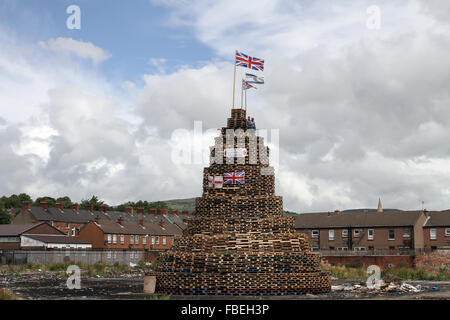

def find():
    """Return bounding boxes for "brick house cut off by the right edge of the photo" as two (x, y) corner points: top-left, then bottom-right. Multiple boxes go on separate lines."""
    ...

(423, 210), (450, 250)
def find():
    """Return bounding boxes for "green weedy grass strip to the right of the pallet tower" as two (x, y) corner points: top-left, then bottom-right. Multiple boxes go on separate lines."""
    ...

(322, 264), (450, 281)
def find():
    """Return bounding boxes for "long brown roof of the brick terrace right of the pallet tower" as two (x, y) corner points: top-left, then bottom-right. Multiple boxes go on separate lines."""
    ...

(294, 211), (423, 229)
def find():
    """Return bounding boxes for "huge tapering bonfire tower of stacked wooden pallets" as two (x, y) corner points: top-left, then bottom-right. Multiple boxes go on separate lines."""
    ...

(154, 109), (331, 295)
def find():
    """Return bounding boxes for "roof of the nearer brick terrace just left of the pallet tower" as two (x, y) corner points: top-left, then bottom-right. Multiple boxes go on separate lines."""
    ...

(94, 220), (182, 235)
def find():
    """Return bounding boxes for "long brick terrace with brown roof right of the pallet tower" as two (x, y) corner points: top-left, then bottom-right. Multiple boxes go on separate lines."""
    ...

(294, 211), (426, 251)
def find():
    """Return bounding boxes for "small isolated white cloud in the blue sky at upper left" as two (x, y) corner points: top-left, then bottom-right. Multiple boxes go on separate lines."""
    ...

(39, 37), (111, 65)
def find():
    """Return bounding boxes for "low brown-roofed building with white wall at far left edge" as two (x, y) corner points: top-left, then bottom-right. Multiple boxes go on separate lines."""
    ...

(0, 222), (92, 250)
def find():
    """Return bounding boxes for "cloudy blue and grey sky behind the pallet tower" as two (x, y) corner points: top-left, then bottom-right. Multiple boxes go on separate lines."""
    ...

(0, 0), (450, 212)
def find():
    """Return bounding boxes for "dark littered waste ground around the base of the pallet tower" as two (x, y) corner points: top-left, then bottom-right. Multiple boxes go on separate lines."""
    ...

(0, 272), (450, 300)
